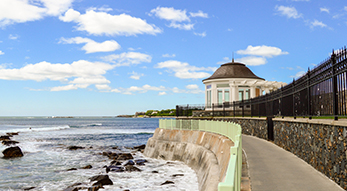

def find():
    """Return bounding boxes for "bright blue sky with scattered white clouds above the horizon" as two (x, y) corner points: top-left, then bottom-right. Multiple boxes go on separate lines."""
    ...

(0, 0), (347, 116)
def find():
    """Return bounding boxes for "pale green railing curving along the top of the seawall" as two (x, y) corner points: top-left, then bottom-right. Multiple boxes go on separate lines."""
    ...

(159, 119), (242, 191)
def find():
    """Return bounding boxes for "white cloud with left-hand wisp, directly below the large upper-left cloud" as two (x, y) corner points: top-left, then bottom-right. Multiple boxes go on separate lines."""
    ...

(59, 37), (120, 54)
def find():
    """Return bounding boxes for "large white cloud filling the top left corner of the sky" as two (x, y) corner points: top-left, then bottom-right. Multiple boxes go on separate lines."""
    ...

(0, 0), (73, 27)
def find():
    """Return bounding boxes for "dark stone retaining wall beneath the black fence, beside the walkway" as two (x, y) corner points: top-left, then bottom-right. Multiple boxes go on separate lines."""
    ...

(207, 117), (347, 190)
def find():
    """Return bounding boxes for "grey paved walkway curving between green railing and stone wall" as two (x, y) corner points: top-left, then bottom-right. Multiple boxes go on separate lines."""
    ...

(242, 135), (343, 191)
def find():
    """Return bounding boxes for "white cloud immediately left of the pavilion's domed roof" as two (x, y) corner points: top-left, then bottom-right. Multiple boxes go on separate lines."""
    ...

(155, 60), (217, 79)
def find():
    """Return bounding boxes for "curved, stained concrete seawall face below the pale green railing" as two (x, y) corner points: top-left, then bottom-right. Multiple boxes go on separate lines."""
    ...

(144, 128), (234, 191)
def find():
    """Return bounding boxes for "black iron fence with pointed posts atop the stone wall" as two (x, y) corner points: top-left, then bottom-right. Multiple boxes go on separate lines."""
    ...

(176, 47), (347, 120)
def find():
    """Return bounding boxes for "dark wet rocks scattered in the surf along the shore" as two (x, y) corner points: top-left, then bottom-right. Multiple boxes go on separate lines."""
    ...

(0, 133), (190, 191)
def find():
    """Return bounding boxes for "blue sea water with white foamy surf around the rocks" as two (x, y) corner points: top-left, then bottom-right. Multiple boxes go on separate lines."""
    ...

(0, 117), (198, 191)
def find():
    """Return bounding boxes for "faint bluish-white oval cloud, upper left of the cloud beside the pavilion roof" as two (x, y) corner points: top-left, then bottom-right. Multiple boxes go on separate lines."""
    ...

(101, 52), (152, 67)
